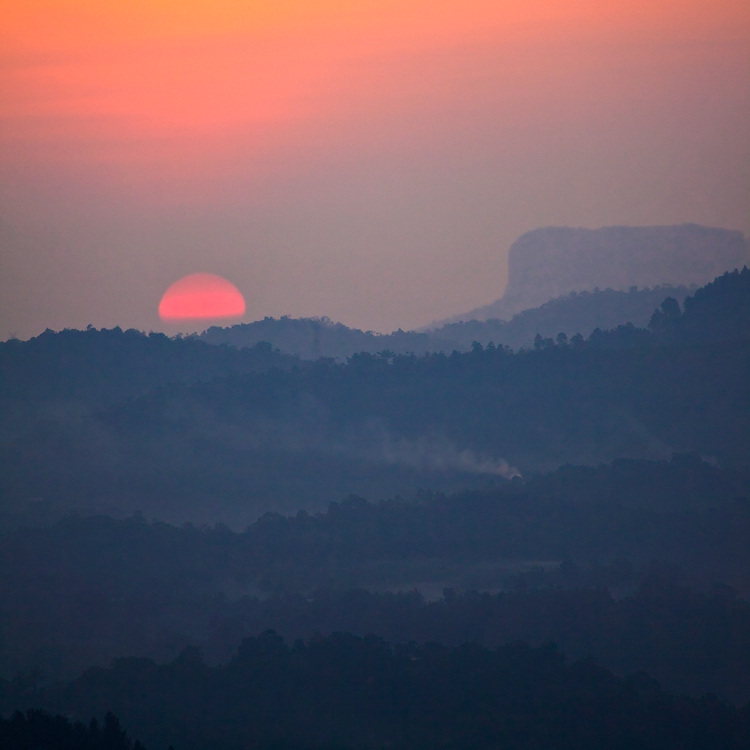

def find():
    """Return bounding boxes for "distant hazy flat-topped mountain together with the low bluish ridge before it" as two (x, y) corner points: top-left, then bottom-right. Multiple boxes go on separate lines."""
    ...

(200, 224), (750, 361)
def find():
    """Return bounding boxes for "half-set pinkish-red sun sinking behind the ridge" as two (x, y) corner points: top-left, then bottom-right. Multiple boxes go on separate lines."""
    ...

(159, 273), (245, 321)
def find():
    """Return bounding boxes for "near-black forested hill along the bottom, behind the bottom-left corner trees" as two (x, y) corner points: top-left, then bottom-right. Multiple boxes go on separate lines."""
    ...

(4, 631), (750, 750)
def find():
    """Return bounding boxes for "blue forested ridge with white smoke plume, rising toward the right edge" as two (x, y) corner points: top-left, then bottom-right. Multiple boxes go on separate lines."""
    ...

(0, 271), (750, 525)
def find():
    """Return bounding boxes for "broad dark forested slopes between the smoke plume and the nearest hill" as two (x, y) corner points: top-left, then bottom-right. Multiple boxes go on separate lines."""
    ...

(0, 456), (750, 702)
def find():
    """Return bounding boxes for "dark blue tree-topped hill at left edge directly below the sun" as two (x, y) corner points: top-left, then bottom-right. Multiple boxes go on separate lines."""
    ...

(0, 327), (296, 440)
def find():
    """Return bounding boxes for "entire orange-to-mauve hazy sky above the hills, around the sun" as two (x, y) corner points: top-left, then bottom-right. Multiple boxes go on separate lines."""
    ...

(0, 0), (750, 339)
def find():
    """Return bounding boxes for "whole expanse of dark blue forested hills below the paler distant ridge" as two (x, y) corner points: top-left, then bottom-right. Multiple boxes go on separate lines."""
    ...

(0, 269), (750, 750)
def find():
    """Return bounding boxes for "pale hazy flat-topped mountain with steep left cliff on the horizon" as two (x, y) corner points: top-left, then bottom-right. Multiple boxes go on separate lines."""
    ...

(457, 224), (750, 320)
